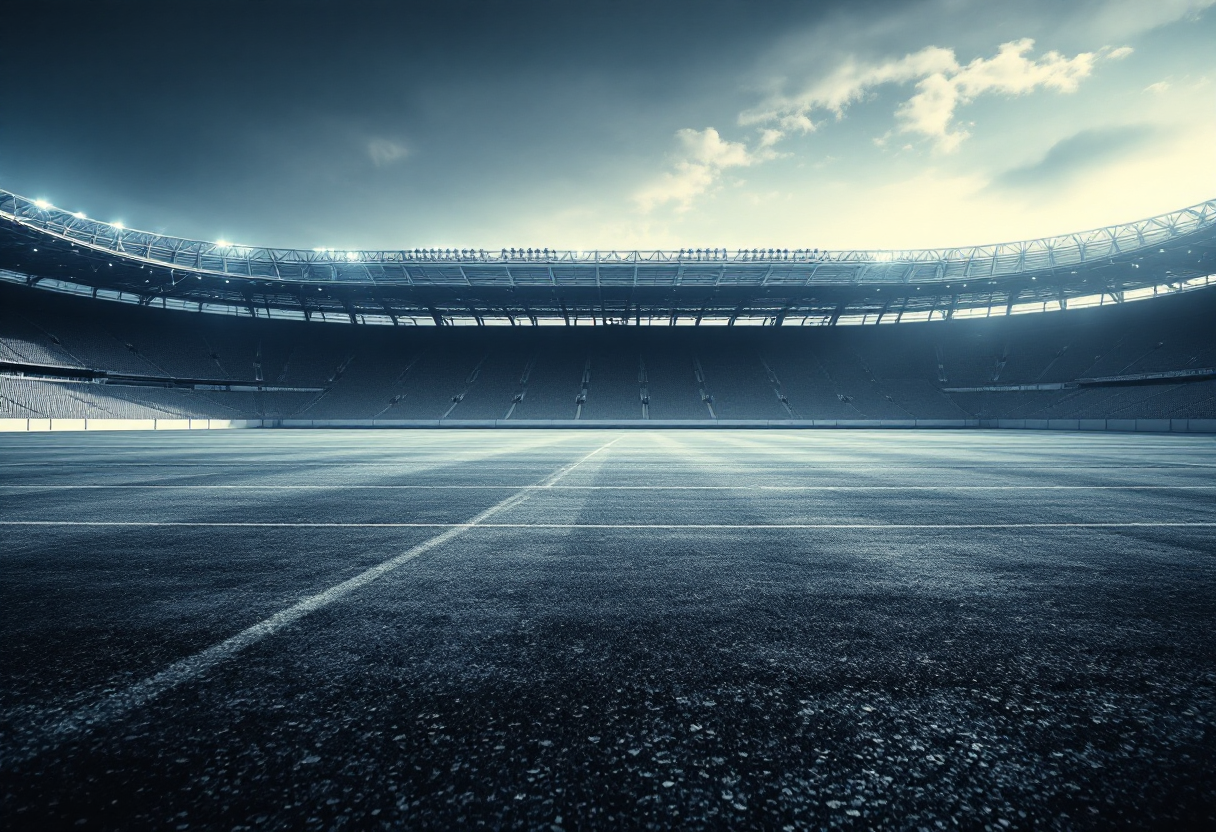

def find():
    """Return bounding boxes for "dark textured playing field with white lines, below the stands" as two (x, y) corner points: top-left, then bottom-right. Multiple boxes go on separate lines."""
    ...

(0, 431), (1216, 830)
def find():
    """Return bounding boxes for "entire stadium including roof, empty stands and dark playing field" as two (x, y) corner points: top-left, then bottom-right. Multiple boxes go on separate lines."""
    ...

(0, 192), (1216, 828)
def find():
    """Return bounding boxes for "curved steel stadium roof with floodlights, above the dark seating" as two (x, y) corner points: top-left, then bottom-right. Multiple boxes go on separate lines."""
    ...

(0, 190), (1216, 326)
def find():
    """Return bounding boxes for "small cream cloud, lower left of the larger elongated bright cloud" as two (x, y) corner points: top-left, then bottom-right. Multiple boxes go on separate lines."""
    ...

(634, 128), (783, 212)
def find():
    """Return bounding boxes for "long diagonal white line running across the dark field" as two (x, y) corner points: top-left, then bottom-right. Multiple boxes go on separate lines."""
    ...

(2, 435), (620, 766)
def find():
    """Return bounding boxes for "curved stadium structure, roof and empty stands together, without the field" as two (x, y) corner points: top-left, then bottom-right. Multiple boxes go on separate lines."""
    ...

(0, 191), (1216, 431)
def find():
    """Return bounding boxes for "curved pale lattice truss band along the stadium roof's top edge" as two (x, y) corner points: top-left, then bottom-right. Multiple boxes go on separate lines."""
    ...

(0, 190), (1216, 283)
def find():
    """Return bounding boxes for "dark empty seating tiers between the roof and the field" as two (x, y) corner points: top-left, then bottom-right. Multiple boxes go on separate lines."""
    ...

(0, 279), (1216, 425)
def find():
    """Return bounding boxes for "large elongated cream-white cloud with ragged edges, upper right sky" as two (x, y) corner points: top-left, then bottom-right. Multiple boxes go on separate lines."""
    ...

(739, 38), (1118, 152)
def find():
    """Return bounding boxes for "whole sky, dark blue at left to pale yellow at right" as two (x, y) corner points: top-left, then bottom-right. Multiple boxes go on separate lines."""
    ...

(0, 0), (1216, 249)
